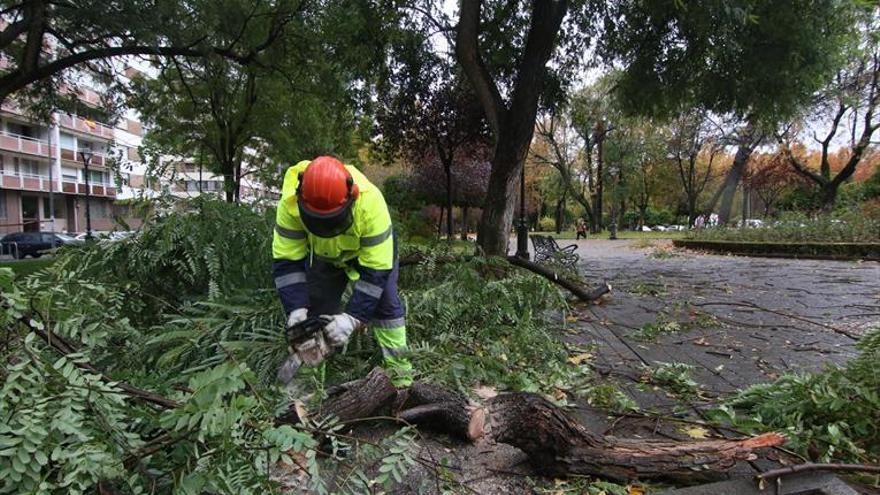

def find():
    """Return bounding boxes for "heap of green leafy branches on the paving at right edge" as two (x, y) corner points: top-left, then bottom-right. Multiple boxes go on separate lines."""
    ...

(712, 328), (880, 463)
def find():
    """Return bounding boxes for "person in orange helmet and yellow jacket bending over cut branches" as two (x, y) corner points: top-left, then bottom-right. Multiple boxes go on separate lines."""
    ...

(272, 156), (412, 387)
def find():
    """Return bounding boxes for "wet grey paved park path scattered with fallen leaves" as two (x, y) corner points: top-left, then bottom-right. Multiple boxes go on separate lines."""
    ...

(564, 240), (880, 471)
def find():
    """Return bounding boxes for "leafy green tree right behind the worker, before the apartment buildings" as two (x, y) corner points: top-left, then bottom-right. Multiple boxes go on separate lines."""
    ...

(132, 0), (378, 201)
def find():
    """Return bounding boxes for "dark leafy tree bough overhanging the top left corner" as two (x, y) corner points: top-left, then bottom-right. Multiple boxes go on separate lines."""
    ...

(0, 0), (300, 112)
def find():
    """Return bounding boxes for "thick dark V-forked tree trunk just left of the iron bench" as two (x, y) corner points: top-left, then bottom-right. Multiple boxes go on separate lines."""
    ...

(455, 0), (584, 255)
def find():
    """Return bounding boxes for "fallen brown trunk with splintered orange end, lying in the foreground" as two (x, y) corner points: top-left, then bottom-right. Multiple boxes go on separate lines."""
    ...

(300, 368), (785, 481)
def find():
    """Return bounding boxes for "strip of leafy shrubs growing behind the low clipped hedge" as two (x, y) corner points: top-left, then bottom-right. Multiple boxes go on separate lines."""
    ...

(688, 212), (880, 243)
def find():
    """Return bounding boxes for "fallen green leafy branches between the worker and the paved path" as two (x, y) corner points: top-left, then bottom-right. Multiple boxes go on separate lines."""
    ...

(401, 259), (578, 392)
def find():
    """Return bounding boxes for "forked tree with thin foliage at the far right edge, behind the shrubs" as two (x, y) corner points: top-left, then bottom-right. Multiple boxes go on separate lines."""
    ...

(778, 9), (880, 210)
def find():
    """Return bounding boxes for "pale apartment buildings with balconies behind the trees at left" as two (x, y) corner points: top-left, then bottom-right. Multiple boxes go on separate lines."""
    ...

(0, 61), (280, 234)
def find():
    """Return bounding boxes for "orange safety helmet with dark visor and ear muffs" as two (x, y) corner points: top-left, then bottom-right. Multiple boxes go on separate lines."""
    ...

(296, 156), (358, 237)
